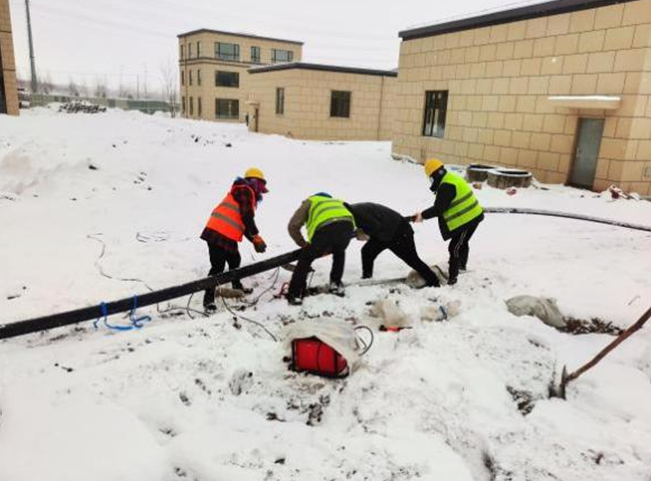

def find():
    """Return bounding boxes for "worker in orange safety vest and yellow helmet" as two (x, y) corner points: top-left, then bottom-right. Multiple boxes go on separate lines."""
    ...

(201, 168), (269, 312)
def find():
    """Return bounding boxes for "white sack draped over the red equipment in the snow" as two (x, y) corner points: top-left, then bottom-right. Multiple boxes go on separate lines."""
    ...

(282, 318), (362, 371)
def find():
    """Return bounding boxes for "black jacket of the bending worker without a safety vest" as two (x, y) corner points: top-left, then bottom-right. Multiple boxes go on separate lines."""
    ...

(345, 202), (411, 244)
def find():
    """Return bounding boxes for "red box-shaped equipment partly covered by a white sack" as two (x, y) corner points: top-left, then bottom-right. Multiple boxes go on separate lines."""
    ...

(290, 337), (349, 377)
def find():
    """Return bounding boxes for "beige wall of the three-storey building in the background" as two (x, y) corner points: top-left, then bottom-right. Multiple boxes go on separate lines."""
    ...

(179, 32), (302, 122)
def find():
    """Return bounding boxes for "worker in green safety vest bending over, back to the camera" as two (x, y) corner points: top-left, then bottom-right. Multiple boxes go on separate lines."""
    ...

(287, 192), (355, 305)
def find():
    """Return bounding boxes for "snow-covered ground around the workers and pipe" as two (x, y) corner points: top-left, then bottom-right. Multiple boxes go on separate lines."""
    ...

(0, 110), (651, 481)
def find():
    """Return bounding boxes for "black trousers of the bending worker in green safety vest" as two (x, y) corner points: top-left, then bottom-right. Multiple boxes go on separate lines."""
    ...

(287, 221), (354, 297)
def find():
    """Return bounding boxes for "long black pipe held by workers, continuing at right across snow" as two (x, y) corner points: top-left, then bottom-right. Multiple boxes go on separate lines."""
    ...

(0, 207), (651, 339)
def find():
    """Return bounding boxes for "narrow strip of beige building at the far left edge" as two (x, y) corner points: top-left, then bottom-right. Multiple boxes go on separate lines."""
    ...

(0, 0), (18, 115)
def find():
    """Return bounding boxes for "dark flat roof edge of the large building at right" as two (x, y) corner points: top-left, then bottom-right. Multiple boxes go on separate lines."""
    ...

(398, 0), (638, 40)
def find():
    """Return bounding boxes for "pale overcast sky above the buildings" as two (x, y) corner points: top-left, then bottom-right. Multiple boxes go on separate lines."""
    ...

(10, 0), (528, 95)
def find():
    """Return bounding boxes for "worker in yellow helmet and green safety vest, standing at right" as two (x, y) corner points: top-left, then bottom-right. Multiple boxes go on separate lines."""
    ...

(412, 159), (484, 285)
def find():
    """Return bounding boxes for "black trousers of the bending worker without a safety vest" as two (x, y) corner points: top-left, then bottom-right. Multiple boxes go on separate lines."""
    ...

(362, 224), (439, 286)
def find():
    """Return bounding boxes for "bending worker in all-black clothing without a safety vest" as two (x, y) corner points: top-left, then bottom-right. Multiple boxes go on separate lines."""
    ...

(344, 202), (439, 287)
